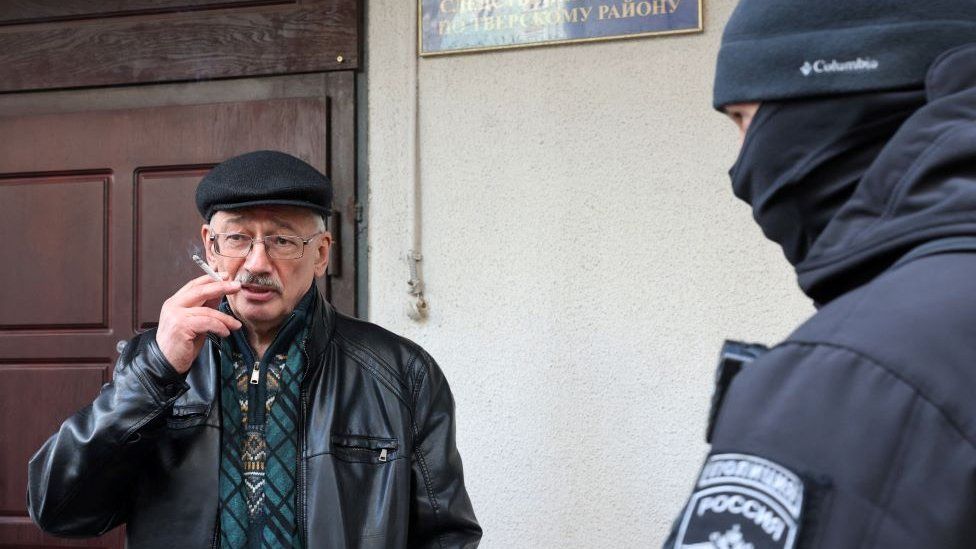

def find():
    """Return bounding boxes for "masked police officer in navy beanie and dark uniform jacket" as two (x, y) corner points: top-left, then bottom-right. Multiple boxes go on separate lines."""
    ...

(665, 0), (976, 549)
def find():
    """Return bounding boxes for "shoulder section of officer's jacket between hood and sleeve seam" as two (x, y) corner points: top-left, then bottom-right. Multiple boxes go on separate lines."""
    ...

(783, 253), (976, 446)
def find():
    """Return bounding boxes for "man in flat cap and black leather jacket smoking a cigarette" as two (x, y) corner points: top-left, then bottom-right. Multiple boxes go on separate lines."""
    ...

(28, 151), (481, 549)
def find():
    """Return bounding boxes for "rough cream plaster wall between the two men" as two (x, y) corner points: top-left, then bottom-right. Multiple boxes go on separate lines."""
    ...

(367, 0), (812, 548)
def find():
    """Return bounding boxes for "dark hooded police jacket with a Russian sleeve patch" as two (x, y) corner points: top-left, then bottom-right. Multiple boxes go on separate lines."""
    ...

(665, 45), (976, 549)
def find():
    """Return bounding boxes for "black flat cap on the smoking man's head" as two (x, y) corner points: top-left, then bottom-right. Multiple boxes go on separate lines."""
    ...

(197, 151), (332, 222)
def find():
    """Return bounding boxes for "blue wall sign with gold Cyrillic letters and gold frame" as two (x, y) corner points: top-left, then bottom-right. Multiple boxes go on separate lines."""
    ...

(418, 0), (703, 56)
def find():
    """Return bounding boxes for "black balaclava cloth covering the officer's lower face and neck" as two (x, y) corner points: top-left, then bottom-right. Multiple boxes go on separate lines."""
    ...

(729, 89), (925, 265)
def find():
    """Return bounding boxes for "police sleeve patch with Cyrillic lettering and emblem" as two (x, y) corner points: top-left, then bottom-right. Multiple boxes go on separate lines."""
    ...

(674, 454), (803, 549)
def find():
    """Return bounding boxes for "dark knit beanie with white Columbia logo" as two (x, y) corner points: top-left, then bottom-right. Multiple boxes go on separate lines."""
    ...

(713, 0), (976, 109)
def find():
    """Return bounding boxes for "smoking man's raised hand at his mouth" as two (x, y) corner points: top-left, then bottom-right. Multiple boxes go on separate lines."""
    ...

(156, 275), (241, 374)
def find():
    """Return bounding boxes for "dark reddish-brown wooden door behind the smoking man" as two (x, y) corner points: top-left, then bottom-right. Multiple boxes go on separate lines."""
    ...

(0, 72), (355, 547)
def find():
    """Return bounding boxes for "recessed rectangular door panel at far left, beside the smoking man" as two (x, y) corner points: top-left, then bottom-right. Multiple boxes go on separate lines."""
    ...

(0, 173), (111, 331)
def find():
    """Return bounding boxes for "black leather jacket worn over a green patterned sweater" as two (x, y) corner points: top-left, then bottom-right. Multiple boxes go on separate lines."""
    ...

(22, 294), (481, 549)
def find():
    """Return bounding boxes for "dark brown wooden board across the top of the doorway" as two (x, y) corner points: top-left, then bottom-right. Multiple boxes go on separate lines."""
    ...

(0, 0), (359, 91)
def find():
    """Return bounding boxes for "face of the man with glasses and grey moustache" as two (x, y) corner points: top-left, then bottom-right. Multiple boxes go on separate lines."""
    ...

(201, 206), (332, 330)
